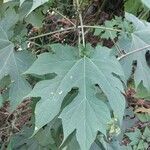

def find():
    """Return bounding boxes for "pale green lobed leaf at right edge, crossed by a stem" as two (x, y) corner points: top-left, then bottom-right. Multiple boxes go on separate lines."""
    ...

(118, 14), (150, 90)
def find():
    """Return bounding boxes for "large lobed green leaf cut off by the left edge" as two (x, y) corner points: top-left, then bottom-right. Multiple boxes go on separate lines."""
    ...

(0, 27), (33, 109)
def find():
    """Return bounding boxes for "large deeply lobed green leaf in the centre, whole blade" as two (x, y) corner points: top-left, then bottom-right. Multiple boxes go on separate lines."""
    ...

(25, 44), (125, 150)
